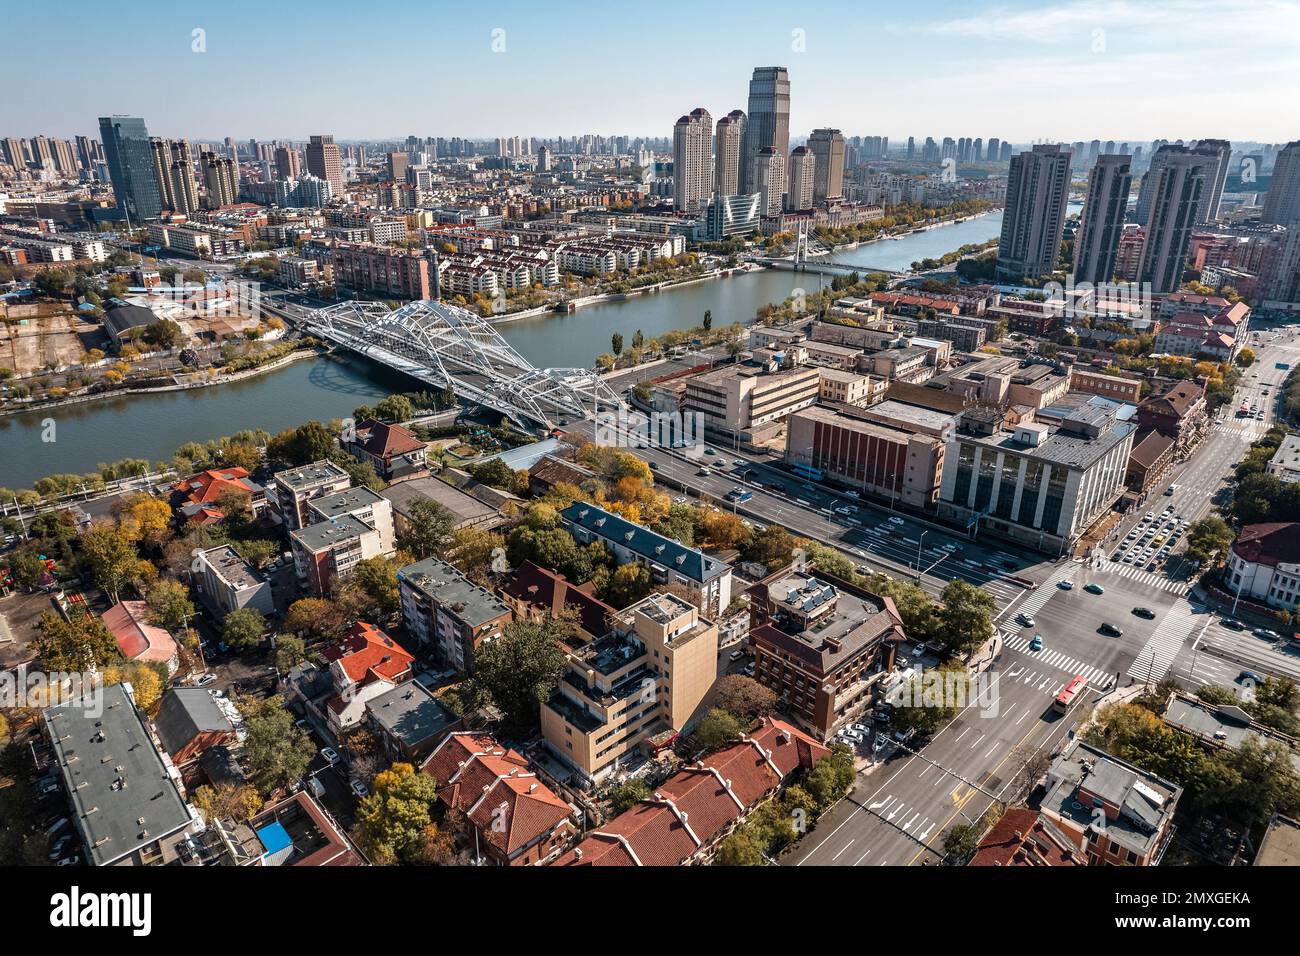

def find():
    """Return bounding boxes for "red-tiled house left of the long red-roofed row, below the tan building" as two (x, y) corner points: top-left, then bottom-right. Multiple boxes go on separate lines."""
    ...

(421, 732), (577, 866)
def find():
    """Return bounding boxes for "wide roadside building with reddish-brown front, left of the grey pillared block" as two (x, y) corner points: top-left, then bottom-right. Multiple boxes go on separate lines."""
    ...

(785, 402), (945, 509)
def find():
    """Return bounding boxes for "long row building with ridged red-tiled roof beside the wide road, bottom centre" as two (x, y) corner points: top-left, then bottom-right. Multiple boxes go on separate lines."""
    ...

(555, 718), (831, 866)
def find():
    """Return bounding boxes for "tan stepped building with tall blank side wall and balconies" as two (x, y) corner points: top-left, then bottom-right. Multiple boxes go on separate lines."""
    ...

(542, 593), (718, 783)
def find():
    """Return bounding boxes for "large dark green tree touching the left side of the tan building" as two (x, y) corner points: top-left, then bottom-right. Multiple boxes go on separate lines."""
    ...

(473, 615), (575, 735)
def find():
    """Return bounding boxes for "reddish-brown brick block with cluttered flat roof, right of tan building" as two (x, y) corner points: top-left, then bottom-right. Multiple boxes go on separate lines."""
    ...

(746, 566), (906, 740)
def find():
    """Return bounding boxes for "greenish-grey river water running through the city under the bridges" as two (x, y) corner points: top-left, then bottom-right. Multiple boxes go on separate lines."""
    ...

(0, 212), (1002, 488)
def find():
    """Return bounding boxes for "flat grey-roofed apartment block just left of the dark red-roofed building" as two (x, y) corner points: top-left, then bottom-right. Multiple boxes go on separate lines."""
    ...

(398, 558), (512, 672)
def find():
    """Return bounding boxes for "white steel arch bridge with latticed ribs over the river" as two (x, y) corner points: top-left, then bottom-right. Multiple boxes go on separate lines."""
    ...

(307, 299), (623, 429)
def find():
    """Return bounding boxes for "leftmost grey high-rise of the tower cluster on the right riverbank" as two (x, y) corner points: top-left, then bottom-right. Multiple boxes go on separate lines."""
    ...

(997, 146), (1070, 278)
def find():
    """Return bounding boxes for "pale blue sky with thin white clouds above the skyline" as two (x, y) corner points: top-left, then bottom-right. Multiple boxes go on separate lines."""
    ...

(0, 0), (1300, 143)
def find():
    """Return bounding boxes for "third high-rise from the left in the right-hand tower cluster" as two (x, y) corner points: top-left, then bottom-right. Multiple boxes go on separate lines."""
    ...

(1139, 146), (1217, 294)
